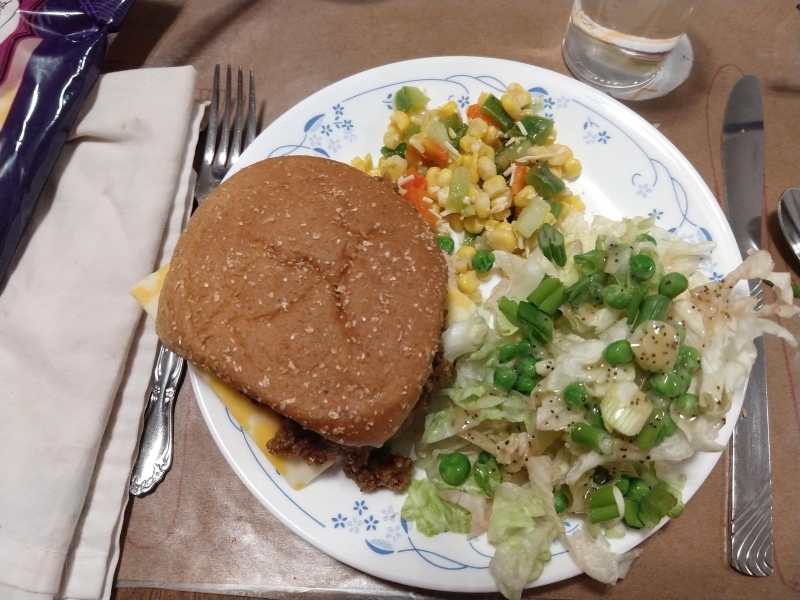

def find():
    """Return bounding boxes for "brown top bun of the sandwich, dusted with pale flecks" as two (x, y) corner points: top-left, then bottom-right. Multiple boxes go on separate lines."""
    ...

(156, 156), (447, 447)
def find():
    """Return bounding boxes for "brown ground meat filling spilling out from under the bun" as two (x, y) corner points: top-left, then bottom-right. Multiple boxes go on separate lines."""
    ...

(267, 352), (452, 492)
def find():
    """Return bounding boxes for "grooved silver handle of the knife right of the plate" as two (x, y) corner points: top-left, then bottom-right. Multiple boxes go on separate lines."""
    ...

(730, 337), (773, 577)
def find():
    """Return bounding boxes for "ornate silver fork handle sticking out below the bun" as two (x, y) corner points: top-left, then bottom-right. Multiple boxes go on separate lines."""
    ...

(129, 342), (186, 496)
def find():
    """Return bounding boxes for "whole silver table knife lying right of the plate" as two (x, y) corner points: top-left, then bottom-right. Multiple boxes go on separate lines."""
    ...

(722, 75), (773, 576)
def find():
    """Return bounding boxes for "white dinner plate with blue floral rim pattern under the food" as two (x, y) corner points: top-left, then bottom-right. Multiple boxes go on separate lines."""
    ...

(191, 57), (742, 592)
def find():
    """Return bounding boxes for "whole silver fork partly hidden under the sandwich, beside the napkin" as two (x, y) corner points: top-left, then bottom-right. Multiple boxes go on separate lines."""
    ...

(129, 65), (256, 496)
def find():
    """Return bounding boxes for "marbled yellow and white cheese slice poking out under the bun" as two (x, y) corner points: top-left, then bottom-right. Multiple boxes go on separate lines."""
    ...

(130, 264), (334, 490)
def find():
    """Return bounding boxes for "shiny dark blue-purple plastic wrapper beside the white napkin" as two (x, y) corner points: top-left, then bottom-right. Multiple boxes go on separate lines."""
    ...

(0, 0), (134, 282)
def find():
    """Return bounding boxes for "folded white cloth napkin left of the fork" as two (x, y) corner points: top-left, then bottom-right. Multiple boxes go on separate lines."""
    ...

(0, 67), (203, 600)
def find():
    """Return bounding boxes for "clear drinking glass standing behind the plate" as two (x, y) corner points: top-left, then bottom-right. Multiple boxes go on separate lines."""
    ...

(562, 0), (695, 92)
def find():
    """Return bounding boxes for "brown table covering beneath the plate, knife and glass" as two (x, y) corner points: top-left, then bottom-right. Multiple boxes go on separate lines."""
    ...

(111, 0), (800, 598)
